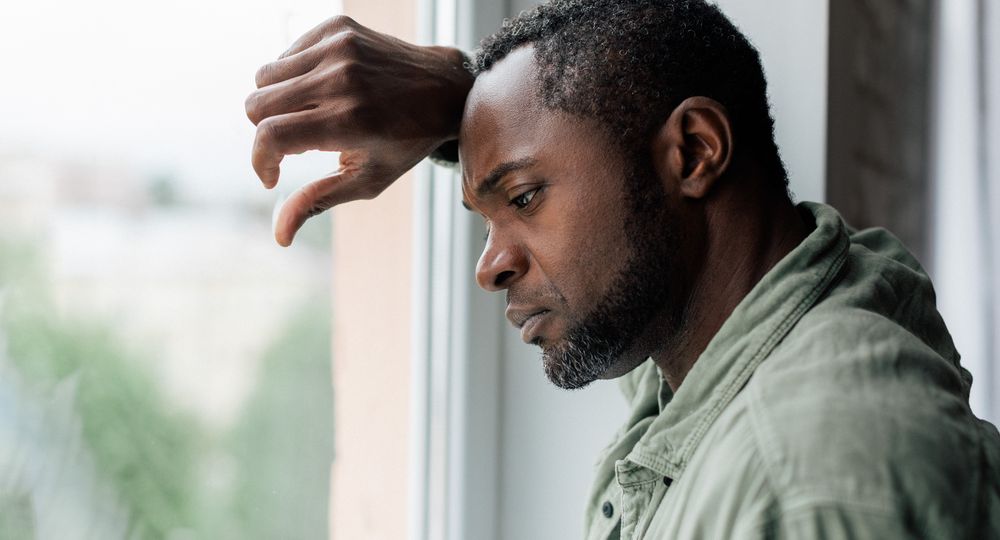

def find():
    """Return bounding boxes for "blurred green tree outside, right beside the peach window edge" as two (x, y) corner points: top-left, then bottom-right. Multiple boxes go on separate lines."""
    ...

(219, 295), (333, 539)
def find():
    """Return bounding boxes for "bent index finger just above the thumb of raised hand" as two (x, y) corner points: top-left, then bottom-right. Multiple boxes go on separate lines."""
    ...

(250, 109), (349, 189)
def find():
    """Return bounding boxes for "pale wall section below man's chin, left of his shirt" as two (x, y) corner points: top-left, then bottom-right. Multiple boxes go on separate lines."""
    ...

(499, 328), (627, 540)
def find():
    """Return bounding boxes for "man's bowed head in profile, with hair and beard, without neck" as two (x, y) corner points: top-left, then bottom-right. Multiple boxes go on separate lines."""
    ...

(461, 0), (785, 388)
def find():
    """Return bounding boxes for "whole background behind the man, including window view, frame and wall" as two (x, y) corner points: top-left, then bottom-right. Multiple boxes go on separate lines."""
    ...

(0, 0), (1000, 540)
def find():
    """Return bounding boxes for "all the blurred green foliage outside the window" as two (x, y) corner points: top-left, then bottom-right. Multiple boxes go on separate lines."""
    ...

(0, 241), (333, 540)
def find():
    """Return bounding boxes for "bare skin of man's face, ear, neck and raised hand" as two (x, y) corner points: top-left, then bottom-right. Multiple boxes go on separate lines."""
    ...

(247, 18), (808, 390)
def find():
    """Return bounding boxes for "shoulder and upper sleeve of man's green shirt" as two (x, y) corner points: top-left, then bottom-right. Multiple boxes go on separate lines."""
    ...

(745, 225), (996, 537)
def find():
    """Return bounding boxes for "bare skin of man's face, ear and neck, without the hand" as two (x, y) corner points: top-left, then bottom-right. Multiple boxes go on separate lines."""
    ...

(460, 47), (807, 390)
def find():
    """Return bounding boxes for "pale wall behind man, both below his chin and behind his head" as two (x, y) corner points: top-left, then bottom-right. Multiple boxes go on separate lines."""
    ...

(492, 0), (827, 540)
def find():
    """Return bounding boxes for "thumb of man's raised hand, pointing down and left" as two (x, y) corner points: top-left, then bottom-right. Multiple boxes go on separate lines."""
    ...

(274, 171), (385, 247)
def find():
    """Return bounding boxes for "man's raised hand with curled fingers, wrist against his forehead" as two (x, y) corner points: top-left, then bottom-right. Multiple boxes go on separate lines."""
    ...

(246, 17), (473, 246)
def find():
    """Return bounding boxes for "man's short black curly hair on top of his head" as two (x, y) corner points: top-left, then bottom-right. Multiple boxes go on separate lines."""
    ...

(471, 0), (788, 191)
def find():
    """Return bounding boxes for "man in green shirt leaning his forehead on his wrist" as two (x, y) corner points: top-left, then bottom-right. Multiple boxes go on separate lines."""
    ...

(247, 0), (1000, 539)
